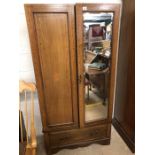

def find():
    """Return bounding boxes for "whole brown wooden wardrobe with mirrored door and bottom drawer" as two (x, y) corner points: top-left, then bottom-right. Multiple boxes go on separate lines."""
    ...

(25, 3), (120, 154)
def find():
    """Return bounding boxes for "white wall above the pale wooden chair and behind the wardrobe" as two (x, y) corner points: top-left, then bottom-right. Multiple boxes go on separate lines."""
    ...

(18, 0), (121, 82)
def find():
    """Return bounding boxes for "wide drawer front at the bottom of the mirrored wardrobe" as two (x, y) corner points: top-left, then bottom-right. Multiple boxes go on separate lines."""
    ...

(50, 126), (107, 147)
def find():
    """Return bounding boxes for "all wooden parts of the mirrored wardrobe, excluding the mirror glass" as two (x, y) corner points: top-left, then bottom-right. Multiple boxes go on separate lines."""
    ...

(25, 3), (120, 154)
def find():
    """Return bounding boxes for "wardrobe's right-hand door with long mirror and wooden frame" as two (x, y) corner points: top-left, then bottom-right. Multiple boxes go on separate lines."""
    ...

(76, 3), (120, 127)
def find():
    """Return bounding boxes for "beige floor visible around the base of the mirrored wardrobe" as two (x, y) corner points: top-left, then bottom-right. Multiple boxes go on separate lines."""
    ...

(37, 127), (134, 155)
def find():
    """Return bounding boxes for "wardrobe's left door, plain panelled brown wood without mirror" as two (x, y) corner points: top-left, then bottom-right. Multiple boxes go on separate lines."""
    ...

(25, 4), (78, 130)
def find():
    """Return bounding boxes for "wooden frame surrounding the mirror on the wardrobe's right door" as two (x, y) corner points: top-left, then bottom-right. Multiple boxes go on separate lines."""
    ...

(76, 3), (121, 128)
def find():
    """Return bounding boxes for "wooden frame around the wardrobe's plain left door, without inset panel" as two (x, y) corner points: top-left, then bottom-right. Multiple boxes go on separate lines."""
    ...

(24, 4), (78, 132)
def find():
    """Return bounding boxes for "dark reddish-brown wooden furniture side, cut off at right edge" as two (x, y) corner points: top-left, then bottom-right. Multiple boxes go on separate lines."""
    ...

(113, 0), (135, 152)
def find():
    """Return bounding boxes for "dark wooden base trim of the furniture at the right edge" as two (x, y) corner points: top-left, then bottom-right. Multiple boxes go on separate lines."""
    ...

(112, 118), (135, 153)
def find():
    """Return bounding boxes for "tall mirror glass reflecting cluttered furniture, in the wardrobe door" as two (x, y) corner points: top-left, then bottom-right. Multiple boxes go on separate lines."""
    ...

(83, 12), (113, 122)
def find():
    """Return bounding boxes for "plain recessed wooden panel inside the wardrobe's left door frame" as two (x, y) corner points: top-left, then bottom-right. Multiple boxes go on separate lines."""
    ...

(35, 13), (73, 125)
